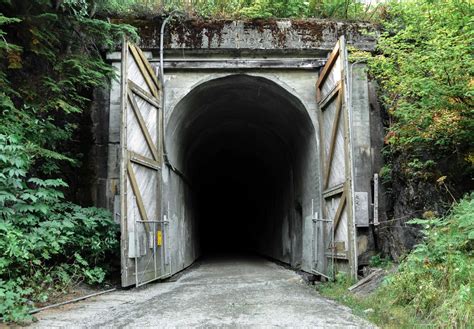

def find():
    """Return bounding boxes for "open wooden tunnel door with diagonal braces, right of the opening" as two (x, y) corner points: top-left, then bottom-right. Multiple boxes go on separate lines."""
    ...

(316, 37), (357, 278)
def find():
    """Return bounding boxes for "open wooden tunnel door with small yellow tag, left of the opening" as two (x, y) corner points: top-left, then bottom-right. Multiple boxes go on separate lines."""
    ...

(120, 42), (167, 286)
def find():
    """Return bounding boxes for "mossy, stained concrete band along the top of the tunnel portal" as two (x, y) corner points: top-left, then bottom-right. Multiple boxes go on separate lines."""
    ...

(113, 18), (377, 53)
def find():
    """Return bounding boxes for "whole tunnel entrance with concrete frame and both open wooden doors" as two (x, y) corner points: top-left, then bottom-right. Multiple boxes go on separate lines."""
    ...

(117, 37), (375, 286)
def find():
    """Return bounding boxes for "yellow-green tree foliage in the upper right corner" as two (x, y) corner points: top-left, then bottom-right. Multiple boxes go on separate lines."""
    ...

(370, 0), (474, 184)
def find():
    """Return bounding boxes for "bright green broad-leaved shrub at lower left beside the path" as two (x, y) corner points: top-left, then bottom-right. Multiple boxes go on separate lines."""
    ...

(0, 134), (118, 321)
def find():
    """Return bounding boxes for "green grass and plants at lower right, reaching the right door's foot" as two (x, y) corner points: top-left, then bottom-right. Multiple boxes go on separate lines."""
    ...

(320, 194), (474, 328)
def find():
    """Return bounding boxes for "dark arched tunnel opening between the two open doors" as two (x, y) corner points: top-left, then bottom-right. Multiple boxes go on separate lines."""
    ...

(166, 75), (316, 266)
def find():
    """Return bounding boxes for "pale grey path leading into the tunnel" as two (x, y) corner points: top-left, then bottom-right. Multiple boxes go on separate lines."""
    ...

(34, 258), (371, 328)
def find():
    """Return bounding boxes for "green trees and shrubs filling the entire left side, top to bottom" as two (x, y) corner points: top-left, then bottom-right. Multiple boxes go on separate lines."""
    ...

(0, 0), (136, 321)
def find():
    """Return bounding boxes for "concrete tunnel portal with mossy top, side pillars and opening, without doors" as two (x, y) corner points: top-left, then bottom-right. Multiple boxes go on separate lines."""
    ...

(96, 21), (377, 284)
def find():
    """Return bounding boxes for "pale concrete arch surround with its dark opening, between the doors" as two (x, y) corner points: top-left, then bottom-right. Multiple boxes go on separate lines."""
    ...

(163, 70), (320, 269)
